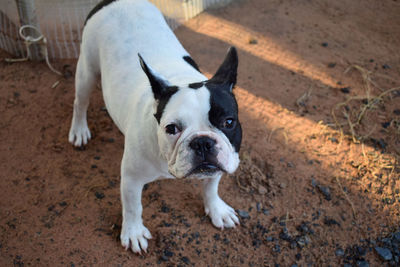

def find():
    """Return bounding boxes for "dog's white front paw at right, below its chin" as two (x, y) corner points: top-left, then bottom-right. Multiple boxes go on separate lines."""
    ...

(205, 197), (240, 229)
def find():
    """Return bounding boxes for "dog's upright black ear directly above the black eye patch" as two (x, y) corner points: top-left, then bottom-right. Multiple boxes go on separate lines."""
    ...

(208, 46), (239, 90)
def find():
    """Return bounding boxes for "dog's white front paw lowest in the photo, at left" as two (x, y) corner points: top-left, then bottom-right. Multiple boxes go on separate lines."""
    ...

(121, 223), (152, 254)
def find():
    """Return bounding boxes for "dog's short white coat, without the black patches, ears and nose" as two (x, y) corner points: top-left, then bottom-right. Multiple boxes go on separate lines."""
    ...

(69, 0), (239, 253)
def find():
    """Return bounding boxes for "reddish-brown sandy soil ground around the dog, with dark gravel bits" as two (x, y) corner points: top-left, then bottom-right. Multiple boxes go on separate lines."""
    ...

(0, 0), (400, 266)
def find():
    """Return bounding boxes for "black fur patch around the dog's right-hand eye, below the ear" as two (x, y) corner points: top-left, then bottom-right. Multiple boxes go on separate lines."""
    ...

(205, 81), (242, 152)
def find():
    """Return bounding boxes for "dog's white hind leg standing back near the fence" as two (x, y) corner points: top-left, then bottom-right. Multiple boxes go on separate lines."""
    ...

(68, 54), (96, 146)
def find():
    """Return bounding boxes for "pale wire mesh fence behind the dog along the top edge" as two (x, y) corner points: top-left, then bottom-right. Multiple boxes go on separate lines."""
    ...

(0, 0), (231, 58)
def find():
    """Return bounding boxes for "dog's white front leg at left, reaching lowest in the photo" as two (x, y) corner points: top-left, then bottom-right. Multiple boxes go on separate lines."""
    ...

(121, 168), (151, 253)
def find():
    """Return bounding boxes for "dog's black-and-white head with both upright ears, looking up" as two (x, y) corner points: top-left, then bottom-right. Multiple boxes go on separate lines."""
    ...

(139, 48), (242, 178)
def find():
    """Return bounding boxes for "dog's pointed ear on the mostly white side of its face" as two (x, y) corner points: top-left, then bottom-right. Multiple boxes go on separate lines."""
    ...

(138, 54), (171, 100)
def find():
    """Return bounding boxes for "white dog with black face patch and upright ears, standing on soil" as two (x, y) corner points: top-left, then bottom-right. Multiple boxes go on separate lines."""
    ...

(69, 0), (242, 253)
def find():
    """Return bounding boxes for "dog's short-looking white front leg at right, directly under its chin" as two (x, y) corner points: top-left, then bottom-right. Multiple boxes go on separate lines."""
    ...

(203, 176), (239, 229)
